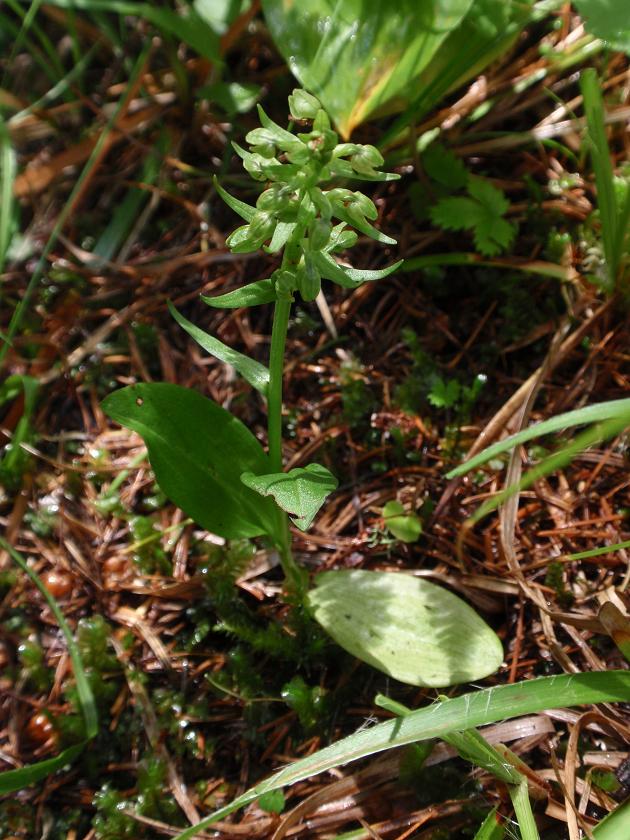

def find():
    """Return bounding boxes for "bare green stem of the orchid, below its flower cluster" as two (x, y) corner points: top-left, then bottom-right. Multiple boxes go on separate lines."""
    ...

(267, 298), (304, 601)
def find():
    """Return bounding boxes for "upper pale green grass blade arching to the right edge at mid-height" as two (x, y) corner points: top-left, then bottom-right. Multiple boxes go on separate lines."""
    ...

(446, 399), (630, 478)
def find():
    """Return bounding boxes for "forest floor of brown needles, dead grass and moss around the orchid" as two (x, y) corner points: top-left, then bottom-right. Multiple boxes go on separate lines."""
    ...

(0, 6), (630, 840)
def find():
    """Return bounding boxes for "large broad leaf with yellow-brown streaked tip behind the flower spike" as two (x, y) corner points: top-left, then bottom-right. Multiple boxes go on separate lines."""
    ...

(262, 0), (472, 139)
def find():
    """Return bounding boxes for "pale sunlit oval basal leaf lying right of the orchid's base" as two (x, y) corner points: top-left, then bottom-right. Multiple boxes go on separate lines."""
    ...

(308, 570), (503, 688)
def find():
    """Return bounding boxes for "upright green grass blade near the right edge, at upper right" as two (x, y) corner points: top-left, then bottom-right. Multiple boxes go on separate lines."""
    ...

(580, 67), (621, 288)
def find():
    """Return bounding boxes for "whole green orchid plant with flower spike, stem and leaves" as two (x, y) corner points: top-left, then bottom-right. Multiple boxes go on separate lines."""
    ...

(103, 90), (502, 686)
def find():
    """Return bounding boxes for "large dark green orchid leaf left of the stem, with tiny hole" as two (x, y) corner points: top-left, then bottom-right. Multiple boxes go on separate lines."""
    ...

(103, 382), (276, 539)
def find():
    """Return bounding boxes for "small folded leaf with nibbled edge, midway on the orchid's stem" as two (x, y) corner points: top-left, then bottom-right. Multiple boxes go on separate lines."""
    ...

(241, 464), (337, 531)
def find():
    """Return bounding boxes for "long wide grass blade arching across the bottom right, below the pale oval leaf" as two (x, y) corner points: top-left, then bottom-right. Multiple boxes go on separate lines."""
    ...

(170, 671), (630, 840)
